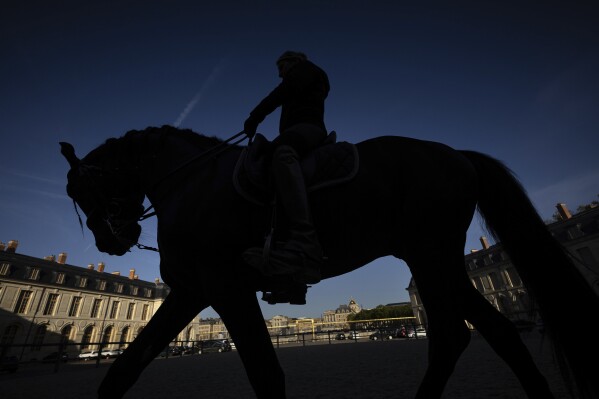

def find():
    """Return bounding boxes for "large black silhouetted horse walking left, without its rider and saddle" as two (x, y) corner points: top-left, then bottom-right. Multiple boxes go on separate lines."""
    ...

(60, 126), (599, 399)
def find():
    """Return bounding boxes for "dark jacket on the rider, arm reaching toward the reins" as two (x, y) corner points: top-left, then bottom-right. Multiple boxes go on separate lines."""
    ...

(249, 61), (330, 133)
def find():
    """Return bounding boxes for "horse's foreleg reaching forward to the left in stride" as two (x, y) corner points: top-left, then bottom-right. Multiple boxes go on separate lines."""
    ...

(98, 291), (206, 399)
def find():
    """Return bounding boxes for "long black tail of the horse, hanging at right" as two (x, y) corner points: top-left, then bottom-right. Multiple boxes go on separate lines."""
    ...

(460, 151), (599, 398)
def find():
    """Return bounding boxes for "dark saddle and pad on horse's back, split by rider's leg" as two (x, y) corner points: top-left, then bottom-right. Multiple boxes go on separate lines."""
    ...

(233, 132), (359, 206)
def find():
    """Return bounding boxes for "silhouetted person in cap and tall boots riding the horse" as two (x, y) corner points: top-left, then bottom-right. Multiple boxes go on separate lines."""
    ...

(243, 51), (330, 284)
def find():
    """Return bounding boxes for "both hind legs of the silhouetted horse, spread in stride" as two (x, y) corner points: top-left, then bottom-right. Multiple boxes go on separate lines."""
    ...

(408, 248), (553, 399)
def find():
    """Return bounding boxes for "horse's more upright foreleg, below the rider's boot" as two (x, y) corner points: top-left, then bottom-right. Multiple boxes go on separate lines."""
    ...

(212, 291), (285, 399)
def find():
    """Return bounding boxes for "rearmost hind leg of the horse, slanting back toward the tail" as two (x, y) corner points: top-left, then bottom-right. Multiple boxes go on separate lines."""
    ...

(463, 284), (554, 399)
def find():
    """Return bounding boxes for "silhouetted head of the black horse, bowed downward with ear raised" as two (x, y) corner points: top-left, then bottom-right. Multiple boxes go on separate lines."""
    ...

(60, 142), (145, 256)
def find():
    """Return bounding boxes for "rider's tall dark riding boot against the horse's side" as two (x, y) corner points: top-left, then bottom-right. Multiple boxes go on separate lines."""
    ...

(243, 145), (322, 284)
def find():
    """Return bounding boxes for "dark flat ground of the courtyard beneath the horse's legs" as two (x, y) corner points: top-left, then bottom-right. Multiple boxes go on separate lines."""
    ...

(0, 332), (572, 399)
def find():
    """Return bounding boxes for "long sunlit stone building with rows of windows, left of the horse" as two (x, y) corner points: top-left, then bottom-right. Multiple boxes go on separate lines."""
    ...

(0, 247), (200, 361)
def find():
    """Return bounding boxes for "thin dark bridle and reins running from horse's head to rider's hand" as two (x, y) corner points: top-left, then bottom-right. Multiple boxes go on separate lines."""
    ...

(69, 131), (251, 252)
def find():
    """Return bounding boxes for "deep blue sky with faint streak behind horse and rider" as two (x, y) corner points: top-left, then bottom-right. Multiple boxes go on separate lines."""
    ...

(0, 0), (599, 318)
